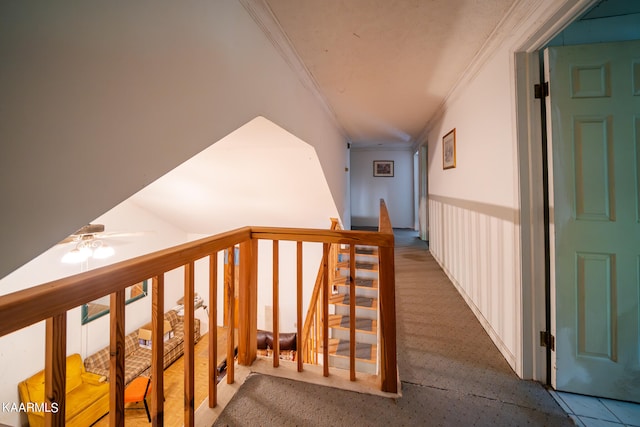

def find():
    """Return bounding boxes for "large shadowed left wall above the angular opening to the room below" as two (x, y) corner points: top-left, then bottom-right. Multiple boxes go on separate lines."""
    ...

(0, 0), (349, 277)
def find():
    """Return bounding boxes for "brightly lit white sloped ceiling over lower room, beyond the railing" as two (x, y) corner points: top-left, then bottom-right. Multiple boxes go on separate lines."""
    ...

(129, 117), (339, 235)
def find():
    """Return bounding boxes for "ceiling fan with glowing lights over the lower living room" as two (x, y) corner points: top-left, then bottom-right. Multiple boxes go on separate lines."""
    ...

(59, 224), (144, 264)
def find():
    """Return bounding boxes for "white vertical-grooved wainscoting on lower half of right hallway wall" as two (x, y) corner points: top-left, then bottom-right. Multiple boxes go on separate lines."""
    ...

(429, 195), (522, 369)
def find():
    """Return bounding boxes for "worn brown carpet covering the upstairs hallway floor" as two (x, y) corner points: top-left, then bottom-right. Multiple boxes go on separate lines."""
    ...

(215, 230), (574, 426)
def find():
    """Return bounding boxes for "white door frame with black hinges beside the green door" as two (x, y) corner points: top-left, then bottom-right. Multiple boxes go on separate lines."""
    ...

(513, 0), (598, 386)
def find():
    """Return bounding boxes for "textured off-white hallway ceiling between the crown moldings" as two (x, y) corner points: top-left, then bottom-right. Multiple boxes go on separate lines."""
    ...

(264, 0), (516, 146)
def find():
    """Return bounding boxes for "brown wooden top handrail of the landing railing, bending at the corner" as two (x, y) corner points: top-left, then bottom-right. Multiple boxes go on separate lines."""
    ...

(0, 227), (393, 336)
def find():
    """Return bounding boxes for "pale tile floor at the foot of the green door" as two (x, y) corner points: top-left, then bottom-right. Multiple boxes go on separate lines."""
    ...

(551, 391), (640, 427)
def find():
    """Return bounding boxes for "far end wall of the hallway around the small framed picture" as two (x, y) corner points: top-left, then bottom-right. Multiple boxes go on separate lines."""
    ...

(350, 147), (415, 228)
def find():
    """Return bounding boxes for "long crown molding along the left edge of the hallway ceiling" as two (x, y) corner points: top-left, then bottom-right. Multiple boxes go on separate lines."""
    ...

(238, 0), (350, 142)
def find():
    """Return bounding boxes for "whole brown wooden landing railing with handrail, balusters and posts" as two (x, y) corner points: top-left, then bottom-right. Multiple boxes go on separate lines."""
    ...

(0, 201), (397, 426)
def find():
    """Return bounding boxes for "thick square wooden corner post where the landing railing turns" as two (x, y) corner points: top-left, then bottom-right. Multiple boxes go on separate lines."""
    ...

(238, 239), (258, 366)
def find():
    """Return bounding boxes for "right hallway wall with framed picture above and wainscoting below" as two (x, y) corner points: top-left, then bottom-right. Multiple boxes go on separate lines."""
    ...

(428, 45), (520, 370)
